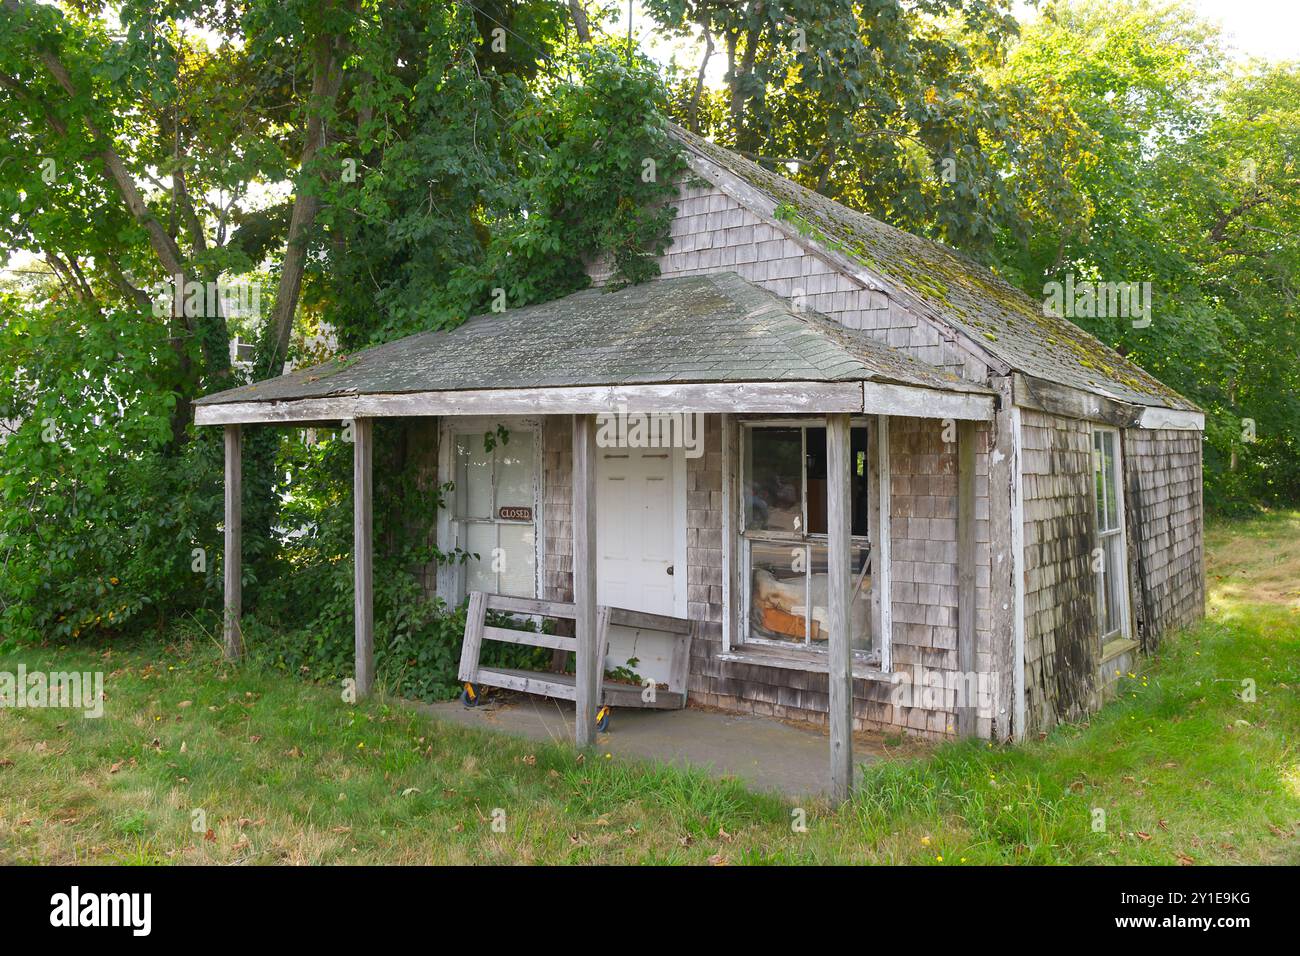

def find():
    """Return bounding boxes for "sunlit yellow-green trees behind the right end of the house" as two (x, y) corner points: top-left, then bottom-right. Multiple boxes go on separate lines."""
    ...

(996, 0), (1300, 511)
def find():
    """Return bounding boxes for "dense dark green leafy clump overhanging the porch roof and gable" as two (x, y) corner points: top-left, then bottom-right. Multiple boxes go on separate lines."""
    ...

(315, 36), (683, 347)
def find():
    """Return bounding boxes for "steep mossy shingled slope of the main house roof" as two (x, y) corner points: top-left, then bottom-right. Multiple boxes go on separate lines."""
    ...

(671, 126), (1196, 410)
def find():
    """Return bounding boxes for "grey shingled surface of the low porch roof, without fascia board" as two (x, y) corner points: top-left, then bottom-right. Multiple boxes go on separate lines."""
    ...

(198, 273), (991, 405)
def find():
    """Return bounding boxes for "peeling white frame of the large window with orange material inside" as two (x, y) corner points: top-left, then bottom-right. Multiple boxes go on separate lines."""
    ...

(743, 415), (884, 667)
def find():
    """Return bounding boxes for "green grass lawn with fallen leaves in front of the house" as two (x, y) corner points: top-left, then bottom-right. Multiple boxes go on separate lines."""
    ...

(0, 514), (1300, 865)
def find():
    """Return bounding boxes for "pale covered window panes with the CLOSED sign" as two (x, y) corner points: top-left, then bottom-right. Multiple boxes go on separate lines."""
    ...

(452, 425), (537, 597)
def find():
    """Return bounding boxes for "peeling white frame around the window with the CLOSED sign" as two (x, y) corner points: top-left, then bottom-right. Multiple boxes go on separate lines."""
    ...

(437, 415), (546, 606)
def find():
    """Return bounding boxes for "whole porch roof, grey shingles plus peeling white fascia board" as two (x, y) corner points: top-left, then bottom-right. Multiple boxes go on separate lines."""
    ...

(195, 273), (993, 424)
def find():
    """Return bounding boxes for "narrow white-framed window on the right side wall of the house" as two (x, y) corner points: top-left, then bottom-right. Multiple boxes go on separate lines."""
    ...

(1092, 427), (1128, 645)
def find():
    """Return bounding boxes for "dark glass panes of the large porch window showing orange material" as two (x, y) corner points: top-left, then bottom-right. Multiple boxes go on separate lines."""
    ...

(741, 423), (872, 654)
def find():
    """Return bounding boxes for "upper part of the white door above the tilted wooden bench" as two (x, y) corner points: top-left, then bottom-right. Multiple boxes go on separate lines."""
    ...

(595, 447), (686, 617)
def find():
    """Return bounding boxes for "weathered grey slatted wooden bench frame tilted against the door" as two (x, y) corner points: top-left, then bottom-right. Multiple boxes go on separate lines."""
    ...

(460, 591), (690, 710)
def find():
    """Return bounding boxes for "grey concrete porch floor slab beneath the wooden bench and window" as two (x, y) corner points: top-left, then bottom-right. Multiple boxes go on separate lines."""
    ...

(417, 695), (904, 797)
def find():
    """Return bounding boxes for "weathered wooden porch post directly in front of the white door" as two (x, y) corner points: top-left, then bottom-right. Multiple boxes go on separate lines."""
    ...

(573, 415), (601, 747)
